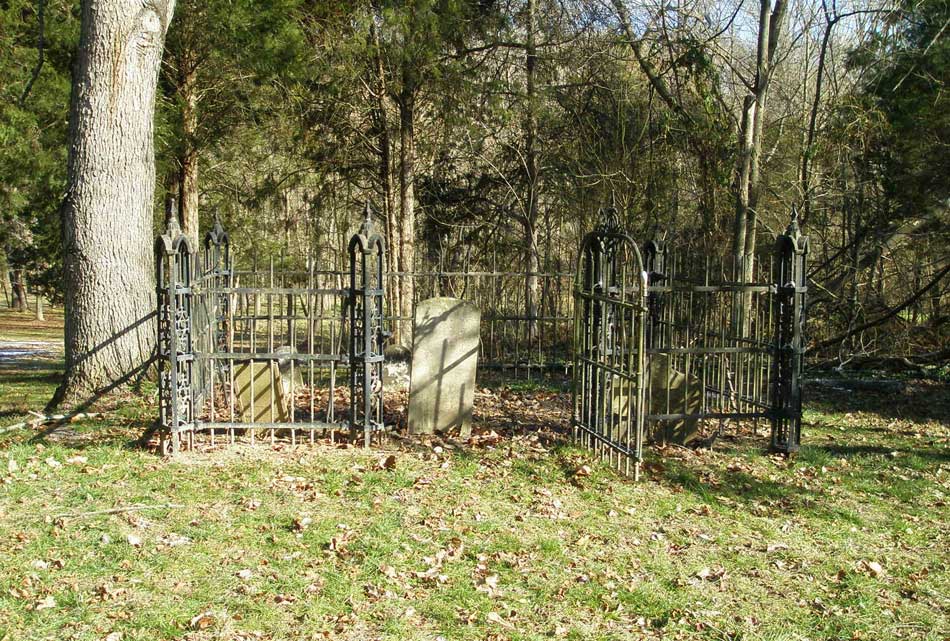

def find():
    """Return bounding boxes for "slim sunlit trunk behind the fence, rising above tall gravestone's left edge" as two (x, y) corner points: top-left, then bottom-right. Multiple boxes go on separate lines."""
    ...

(399, 86), (416, 346)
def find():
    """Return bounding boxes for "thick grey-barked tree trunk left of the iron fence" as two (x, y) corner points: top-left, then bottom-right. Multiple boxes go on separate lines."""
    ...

(50, 0), (175, 406)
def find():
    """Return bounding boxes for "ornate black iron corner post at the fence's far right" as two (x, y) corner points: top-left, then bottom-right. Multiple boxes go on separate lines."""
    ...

(771, 211), (808, 454)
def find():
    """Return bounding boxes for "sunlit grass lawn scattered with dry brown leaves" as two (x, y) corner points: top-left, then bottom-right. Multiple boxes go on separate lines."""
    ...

(0, 308), (950, 641)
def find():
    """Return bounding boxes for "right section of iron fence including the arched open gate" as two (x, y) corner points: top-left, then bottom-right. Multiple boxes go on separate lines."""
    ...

(572, 209), (808, 477)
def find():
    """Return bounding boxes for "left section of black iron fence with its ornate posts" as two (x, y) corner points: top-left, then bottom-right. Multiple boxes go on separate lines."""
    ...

(155, 205), (388, 453)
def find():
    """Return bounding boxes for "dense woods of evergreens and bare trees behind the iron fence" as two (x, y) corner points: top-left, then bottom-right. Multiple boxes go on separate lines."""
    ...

(0, 0), (950, 400)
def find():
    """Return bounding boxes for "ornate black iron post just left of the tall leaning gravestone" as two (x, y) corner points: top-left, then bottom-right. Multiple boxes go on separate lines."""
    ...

(349, 202), (388, 447)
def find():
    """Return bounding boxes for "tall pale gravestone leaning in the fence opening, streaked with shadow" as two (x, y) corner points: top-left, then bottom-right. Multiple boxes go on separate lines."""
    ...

(409, 298), (481, 438)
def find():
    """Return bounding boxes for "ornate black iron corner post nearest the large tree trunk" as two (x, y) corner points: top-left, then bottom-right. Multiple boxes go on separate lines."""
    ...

(155, 206), (195, 454)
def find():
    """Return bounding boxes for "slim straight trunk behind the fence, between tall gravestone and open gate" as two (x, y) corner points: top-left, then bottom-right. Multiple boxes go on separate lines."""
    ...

(524, 0), (541, 340)
